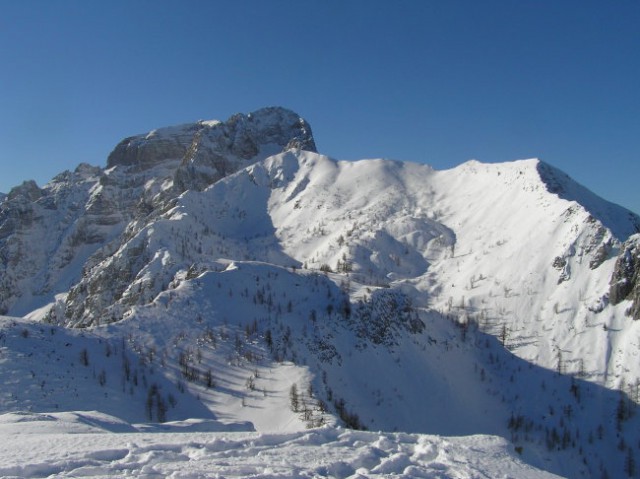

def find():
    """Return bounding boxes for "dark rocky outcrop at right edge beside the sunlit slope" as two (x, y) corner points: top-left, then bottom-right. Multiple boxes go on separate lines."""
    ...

(609, 235), (640, 320)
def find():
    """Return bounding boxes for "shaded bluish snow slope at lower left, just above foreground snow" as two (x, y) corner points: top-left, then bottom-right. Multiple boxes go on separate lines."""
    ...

(0, 317), (214, 422)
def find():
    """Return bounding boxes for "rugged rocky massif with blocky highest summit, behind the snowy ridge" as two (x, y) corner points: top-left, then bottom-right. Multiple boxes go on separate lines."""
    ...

(0, 107), (315, 315)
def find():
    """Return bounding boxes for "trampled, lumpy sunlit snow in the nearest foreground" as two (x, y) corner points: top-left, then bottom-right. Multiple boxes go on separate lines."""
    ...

(0, 413), (558, 479)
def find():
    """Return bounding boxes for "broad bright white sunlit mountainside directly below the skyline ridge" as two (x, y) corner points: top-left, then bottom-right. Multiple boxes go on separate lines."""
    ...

(235, 153), (640, 387)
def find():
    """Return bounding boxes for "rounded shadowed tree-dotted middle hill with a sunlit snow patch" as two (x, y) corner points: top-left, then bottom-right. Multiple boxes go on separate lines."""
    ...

(9, 256), (640, 477)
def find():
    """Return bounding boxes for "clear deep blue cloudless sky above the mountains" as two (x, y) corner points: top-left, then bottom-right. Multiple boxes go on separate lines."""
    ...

(0, 0), (640, 213)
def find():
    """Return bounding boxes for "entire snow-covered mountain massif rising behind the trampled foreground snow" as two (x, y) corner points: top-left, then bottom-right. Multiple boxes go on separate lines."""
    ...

(0, 108), (640, 477)
